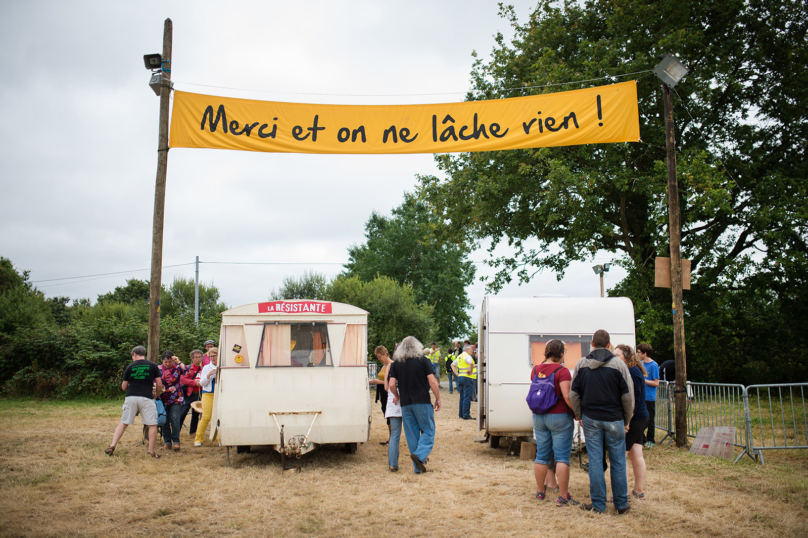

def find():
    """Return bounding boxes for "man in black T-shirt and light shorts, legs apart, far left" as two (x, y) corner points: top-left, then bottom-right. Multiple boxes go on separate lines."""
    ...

(104, 346), (163, 458)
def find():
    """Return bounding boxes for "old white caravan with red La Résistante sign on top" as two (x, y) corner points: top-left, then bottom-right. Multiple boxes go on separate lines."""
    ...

(210, 300), (371, 464)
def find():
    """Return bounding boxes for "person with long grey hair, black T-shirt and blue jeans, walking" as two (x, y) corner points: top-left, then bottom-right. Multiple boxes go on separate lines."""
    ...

(388, 336), (440, 474)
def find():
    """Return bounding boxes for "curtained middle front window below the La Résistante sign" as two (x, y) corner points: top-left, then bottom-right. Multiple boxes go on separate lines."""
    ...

(256, 322), (333, 367)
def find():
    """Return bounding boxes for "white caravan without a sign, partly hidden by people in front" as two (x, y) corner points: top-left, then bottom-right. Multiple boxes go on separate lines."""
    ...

(477, 296), (635, 447)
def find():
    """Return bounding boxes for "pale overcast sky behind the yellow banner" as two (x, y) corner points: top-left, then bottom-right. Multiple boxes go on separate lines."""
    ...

(0, 0), (625, 322)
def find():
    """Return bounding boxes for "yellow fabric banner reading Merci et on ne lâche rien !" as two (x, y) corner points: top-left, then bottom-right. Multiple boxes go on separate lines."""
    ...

(169, 81), (640, 153)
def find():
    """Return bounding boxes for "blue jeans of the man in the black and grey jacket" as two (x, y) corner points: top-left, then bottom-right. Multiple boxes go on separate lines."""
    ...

(583, 415), (628, 512)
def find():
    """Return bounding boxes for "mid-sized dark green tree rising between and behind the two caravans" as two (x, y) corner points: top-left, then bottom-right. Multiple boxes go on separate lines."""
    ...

(345, 194), (475, 341)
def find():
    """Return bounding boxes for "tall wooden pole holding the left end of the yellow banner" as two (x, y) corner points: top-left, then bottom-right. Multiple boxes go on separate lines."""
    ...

(148, 19), (173, 362)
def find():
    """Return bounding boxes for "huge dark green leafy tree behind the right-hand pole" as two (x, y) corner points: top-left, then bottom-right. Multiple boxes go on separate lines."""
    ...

(419, 0), (808, 382)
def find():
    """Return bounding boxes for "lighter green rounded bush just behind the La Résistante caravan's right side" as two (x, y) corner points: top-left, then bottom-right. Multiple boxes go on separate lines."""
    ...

(328, 276), (437, 353)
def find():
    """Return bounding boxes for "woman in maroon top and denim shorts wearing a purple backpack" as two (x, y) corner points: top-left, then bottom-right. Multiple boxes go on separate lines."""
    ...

(527, 340), (579, 507)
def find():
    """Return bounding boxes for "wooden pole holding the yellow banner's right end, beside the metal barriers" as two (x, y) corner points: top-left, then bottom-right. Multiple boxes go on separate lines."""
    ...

(662, 84), (687, 447)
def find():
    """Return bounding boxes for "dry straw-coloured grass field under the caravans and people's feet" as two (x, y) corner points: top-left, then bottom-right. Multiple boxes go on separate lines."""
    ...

(0, 391), (808, 538)
